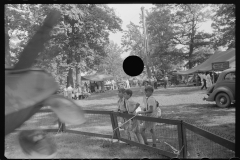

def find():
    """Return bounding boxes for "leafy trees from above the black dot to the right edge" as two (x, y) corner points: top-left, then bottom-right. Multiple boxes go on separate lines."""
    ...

(122, 4), (232, 75)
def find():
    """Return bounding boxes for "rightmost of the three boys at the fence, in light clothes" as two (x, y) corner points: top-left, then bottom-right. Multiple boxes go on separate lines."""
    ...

(138, 86), (158, 147)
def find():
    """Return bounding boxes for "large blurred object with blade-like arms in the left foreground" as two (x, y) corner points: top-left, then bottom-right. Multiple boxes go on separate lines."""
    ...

(5, 11), (85, 158)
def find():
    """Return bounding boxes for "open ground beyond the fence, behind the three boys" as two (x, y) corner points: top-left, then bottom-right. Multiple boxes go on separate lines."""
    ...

(77, 87), (235, 141)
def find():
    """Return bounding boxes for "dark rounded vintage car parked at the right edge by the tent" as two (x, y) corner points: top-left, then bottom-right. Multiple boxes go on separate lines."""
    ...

(204, 68), (235, 108)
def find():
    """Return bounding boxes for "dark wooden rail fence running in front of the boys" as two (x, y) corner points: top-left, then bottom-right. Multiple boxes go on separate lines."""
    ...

(14, 109), (235, 158)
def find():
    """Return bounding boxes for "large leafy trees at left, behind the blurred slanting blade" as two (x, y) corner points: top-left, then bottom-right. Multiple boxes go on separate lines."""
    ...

(5, 4), (122, 86)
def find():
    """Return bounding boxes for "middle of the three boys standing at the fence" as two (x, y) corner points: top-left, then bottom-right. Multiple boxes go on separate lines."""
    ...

(124, 89), (144, 144)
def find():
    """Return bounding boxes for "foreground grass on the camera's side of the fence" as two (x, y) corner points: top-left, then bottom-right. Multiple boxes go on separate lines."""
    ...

(5, 133), (166, 159)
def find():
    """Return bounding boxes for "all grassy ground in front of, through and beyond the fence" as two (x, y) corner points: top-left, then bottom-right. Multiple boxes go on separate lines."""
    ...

(5, 87), (235, 158)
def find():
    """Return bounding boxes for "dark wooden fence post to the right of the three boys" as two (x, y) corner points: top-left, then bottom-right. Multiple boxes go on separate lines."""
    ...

(177, 120), (187, 158)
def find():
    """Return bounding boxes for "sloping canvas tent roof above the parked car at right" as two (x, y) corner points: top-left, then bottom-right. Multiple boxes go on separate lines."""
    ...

(175, 48), (236, 75)
